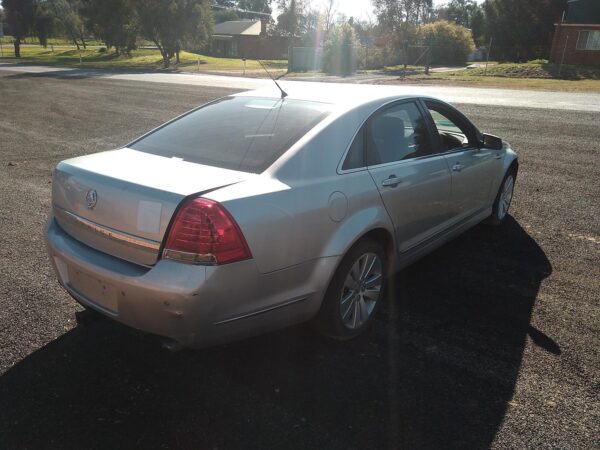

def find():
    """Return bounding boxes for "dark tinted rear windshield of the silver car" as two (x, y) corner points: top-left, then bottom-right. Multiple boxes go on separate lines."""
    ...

(129, 97), (330, 173)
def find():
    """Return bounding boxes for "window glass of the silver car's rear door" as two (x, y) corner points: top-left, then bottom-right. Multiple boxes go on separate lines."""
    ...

(367, 102), (431, 166)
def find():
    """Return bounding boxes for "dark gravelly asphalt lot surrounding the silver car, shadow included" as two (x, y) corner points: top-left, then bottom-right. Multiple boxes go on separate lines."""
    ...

(0, 72), (600, 449)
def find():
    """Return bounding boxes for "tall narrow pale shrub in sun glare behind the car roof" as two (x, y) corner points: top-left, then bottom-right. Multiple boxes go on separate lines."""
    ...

(323, 24), (359, 76)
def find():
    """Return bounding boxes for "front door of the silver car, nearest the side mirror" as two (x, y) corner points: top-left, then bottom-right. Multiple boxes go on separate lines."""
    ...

(424, 100), (502, 222)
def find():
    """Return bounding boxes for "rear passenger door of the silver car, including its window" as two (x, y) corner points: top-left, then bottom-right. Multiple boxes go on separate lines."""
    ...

(366, 100), (452, 252)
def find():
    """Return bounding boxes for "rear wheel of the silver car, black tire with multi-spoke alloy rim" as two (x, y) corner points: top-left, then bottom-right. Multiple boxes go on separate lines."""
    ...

(314, 239), (389, 341)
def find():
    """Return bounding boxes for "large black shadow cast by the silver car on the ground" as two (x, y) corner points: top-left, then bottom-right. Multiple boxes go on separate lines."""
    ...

(0, 218), (560, 449)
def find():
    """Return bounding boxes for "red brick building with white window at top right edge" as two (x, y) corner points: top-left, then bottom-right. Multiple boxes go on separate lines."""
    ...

(550, 0), (600, 65)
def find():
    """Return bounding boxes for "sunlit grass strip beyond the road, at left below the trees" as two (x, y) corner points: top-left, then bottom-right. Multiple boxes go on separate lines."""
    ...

(0, 45), (287, 75)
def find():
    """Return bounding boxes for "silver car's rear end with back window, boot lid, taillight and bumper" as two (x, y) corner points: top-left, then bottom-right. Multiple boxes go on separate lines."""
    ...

(47, 98), (338, 346)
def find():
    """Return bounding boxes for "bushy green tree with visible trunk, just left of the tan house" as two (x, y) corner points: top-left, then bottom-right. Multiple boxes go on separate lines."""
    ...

(132, 0), (213, 68)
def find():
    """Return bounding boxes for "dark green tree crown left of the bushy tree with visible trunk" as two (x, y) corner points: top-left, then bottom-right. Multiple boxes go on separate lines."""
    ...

(82, 0), (138, 55)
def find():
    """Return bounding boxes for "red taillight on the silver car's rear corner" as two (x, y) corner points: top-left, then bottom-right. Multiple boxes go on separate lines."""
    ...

(163, 198), (252, 264)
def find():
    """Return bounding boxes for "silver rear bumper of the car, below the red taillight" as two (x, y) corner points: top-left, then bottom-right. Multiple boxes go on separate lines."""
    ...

(46, 216), (337, 347)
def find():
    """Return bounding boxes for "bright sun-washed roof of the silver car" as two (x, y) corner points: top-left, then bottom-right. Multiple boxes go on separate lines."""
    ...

(235, 81), (423, 108)
